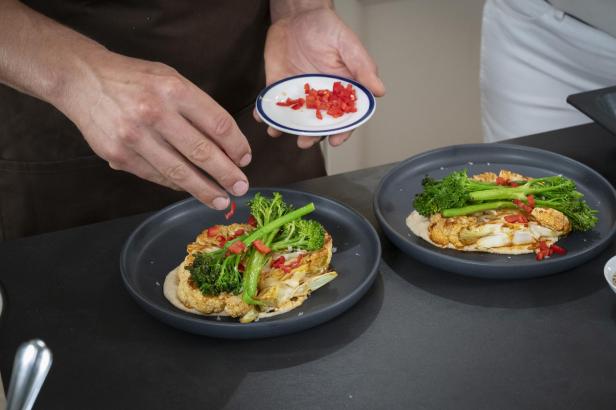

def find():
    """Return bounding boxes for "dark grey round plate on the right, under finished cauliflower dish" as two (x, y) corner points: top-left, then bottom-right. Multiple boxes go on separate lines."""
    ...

(374, 144), (616, 279)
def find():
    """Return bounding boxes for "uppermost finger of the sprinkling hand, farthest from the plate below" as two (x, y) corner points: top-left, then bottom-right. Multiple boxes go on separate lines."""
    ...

(178, 83), (252, 167)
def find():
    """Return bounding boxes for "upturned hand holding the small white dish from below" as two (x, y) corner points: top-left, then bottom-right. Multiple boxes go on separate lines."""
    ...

(255, 7), (385, 148)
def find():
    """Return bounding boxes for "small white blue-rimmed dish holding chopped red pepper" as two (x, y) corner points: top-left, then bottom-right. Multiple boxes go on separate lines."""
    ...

(256, 74), (376, 137)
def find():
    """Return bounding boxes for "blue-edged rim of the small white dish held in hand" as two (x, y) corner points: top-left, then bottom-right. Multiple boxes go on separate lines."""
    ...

(255, 74), (376, 136)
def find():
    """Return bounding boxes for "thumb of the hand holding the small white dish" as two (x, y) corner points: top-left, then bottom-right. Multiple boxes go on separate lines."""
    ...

(340, 30), (385, 97)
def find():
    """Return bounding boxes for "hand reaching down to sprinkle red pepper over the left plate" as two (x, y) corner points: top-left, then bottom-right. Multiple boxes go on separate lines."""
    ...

(56, 50), (252, 210)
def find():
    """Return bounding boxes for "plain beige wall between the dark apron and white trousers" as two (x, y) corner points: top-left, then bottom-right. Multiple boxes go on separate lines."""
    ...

(326, 0), (484, 174)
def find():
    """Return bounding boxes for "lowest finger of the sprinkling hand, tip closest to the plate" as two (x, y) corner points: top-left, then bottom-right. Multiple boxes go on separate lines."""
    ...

(135, 129), (230, 210)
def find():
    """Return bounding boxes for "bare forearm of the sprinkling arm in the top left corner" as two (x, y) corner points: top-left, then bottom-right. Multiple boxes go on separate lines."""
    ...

(0, 0), (105, 106)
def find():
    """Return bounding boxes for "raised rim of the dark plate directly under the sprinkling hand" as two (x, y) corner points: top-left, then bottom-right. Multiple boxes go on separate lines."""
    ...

(119, 187), (382, 339)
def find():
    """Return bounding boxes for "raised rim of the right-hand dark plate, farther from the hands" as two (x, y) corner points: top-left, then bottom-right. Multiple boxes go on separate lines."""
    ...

(372, 143), (616, 279)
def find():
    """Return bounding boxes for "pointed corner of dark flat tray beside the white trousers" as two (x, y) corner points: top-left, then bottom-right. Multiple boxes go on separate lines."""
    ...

(567, 87), (616, 135)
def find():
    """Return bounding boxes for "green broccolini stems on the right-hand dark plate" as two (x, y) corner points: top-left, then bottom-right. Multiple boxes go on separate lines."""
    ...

(413, 170), (597, 231)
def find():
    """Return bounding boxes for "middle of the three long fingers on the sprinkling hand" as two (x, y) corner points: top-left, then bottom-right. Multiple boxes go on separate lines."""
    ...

(159, 115), (248, 196)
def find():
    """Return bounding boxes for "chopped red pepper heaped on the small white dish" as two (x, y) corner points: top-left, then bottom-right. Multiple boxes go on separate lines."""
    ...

(276, 81), (357, 120)
